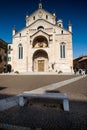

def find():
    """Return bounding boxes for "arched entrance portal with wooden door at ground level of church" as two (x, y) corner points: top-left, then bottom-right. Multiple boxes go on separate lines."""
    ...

(33, 50), (48, 72)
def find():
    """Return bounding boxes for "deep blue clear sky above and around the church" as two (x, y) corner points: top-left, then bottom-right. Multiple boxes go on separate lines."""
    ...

(0, 0), (87, 58)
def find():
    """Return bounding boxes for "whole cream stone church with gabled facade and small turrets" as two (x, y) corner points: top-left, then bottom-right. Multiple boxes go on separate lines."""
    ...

(8, 2), (73, 72)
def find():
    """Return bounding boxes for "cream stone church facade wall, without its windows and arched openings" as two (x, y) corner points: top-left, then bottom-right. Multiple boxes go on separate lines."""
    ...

(10, 2), (73, 72)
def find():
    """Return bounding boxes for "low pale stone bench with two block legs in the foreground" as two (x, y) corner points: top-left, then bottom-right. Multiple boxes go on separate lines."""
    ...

(18, 92), (69, 111)
